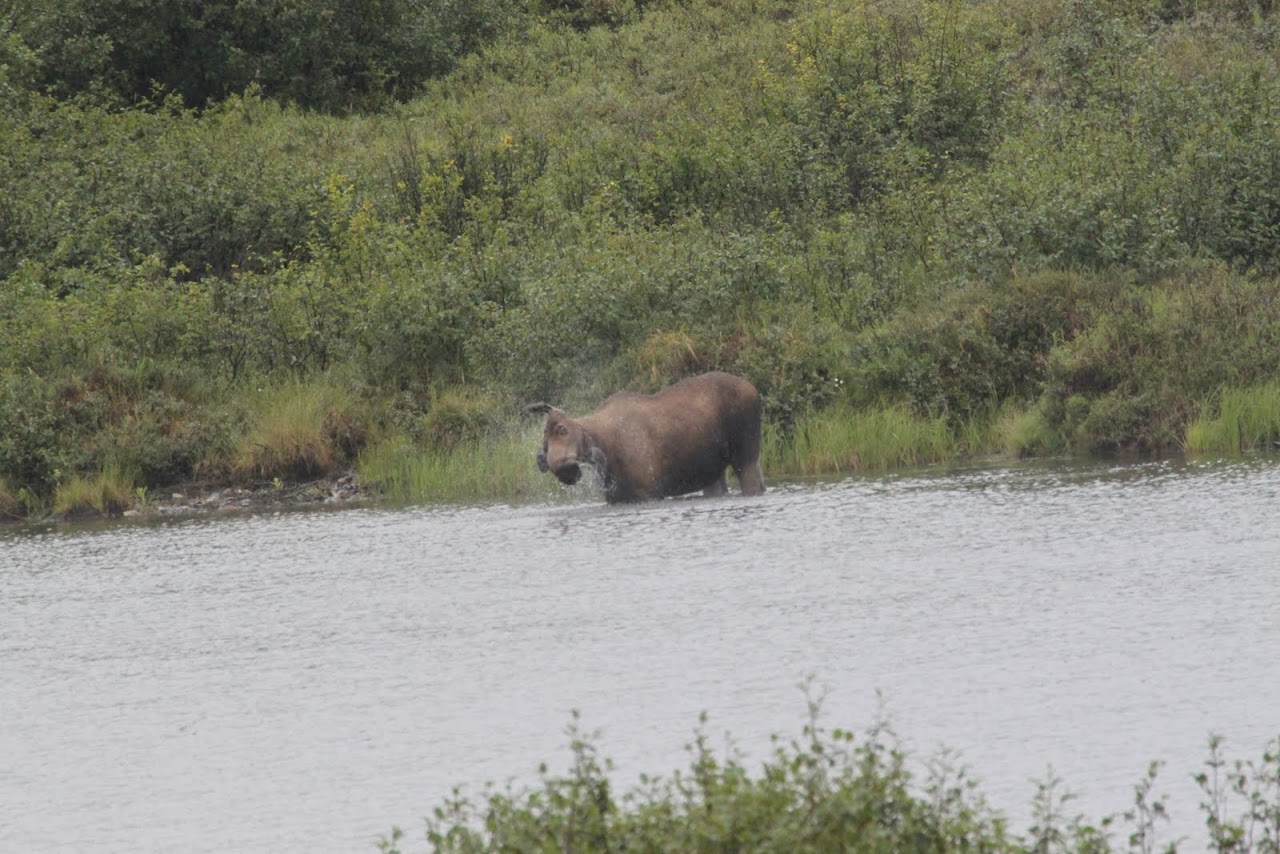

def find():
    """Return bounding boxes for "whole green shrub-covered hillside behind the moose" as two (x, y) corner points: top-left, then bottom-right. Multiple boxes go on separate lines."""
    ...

(0, 0), (1280, 515)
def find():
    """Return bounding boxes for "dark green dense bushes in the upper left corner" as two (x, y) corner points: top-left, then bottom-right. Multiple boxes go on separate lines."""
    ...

(8, 0), (521, 109)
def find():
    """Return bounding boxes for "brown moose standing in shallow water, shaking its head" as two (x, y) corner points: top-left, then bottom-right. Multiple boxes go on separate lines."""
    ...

(527, 371), (764, 504)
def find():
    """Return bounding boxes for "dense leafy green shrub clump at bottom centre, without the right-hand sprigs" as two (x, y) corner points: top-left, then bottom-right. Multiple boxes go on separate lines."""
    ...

(380, 714), (1012, 854)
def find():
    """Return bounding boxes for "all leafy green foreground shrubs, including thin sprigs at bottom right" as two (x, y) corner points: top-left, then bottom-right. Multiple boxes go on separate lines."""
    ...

(379, 712), (1280, 854)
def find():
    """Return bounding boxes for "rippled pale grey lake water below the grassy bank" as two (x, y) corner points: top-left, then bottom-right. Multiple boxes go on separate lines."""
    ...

(0, 460), (1280, 851)
